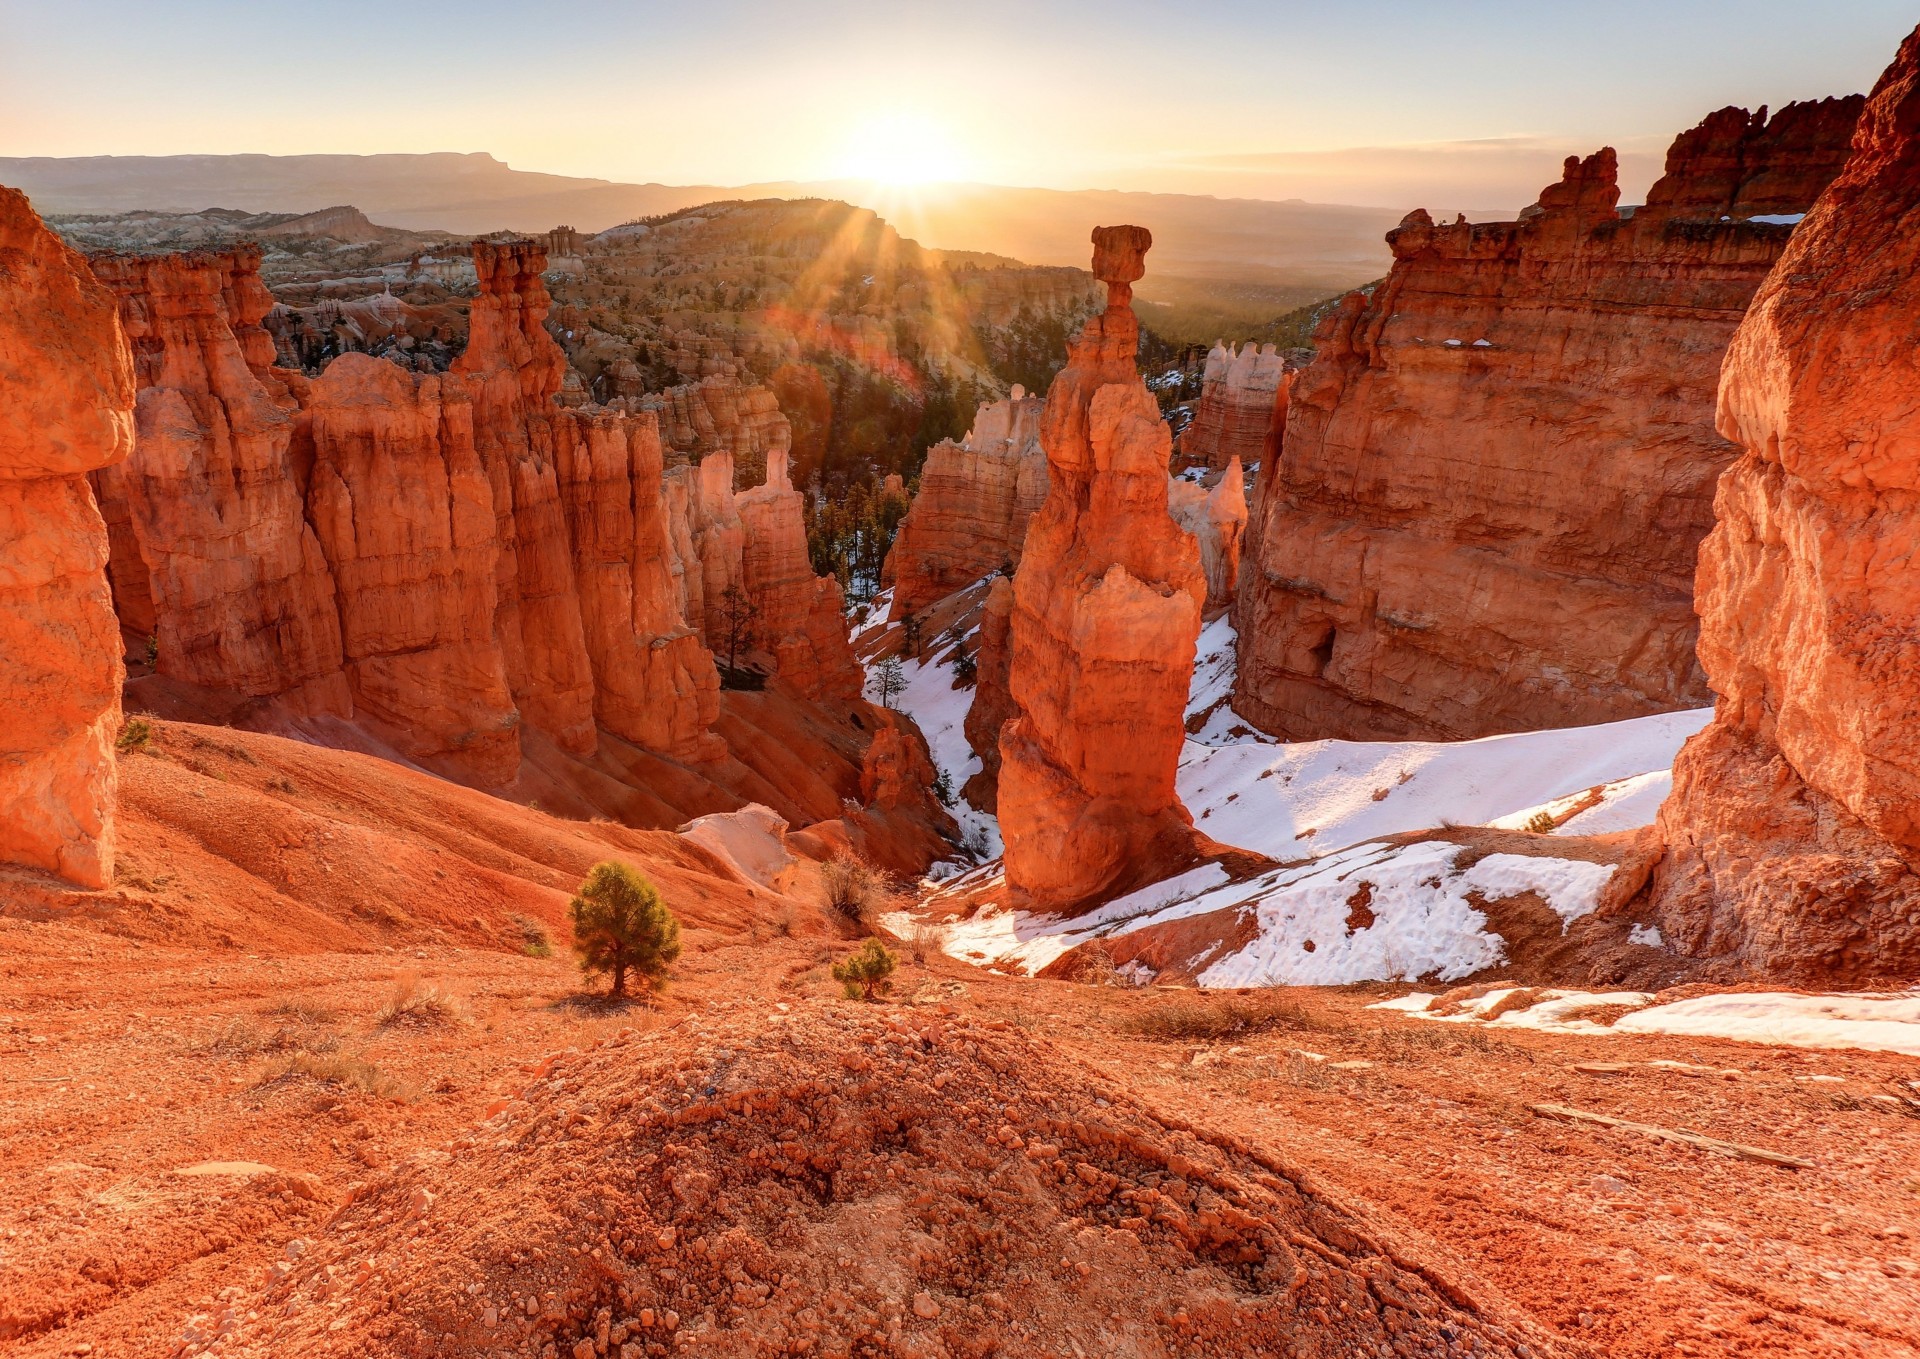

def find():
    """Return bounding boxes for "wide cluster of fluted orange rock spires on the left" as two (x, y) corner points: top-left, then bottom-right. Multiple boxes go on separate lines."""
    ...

(96, 242), (724, 787)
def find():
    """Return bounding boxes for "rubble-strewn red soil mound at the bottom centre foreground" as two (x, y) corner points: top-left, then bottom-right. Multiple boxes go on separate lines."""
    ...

(202, 1006), (1557, 1359)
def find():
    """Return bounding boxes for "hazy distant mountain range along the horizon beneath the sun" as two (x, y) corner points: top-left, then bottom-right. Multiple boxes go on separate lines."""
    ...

(0, 152), (1497, 334)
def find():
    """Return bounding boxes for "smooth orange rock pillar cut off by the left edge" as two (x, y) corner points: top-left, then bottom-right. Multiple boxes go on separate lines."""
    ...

(0, 188), (134, 887)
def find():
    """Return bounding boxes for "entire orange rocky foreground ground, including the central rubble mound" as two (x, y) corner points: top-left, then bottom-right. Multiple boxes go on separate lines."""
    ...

(0, 890), (1920, 1357)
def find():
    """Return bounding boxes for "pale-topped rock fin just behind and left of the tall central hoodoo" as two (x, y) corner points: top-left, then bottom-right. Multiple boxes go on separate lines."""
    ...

(883, 386), (1046, 618)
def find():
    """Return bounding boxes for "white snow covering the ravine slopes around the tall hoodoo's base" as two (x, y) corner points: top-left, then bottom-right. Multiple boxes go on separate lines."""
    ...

(856, 587), (1711, 987)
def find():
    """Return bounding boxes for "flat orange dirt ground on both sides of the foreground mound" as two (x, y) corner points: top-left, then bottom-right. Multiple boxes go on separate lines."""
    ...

(0, 790), (1920, 1359)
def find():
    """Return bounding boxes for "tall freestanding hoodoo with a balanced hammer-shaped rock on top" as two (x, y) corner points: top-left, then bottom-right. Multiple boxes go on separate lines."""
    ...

(998, 227), (1206, 908)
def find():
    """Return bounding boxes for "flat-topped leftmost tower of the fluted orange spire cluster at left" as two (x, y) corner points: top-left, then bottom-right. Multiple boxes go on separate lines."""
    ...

(92, 246), (353, 716)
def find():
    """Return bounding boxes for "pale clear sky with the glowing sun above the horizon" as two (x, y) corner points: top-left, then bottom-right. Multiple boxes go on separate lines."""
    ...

(0, 0), (1916, 205)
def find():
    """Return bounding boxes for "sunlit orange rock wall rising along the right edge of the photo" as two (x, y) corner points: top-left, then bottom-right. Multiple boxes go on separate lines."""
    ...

(1653, 31), (1920, 979)
